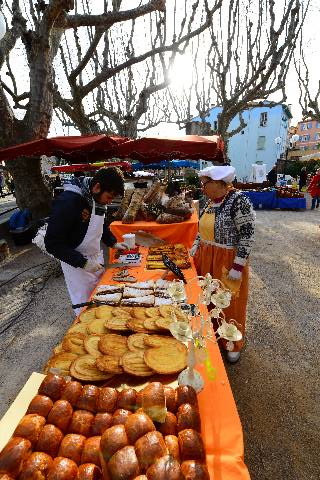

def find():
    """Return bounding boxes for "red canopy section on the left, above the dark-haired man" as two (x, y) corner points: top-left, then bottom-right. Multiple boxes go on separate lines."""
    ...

(0, 135), (128, 161)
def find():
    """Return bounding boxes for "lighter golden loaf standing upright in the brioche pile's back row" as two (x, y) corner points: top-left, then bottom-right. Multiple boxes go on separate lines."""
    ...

(142, 382), (167, 422)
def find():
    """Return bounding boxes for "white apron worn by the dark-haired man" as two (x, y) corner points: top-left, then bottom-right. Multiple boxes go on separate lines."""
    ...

(61, 202), (105, 315)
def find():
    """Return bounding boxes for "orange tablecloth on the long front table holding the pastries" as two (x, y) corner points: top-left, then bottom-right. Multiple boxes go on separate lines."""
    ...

(100, 249), (250, 480)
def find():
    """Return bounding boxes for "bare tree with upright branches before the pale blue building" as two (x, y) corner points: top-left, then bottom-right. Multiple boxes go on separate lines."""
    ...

(171, 0), (309, 154)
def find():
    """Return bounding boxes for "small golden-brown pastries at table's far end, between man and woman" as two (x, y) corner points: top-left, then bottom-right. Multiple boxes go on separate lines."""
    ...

(147, 243), (191, 270)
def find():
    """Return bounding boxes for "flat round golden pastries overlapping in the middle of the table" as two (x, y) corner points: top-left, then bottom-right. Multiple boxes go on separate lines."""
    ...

(45, 302), (188, 380)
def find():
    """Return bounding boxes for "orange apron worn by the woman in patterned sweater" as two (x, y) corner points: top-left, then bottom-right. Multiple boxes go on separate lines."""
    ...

(194, 205), (249, 352)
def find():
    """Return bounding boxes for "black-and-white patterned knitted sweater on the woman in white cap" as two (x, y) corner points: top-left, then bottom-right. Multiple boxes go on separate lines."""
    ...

(194, 190), (255, 273)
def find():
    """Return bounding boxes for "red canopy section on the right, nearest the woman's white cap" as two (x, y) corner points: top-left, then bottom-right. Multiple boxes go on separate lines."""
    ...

(113, 135), (224, 164)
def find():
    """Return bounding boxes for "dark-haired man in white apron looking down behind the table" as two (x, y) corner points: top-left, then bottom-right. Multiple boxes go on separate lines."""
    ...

(45, 167), (126, 315)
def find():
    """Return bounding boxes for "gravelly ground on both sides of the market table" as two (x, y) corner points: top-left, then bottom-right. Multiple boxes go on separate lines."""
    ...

(0, 209), (320, 480)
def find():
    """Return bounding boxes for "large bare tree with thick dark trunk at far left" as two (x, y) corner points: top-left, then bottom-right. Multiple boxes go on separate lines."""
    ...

(0, 0), (223, 217)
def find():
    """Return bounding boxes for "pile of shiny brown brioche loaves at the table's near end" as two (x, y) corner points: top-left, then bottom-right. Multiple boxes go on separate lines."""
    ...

(0, 374), (210, 480)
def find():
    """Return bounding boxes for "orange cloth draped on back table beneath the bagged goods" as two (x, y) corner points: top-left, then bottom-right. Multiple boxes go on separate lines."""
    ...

(110, 211), (198, 248)
